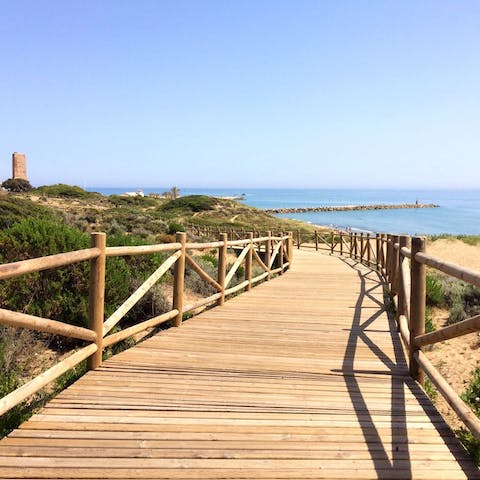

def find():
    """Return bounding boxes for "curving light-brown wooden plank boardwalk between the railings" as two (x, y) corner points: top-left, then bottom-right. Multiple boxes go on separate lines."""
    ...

(0, 251), (480, 479)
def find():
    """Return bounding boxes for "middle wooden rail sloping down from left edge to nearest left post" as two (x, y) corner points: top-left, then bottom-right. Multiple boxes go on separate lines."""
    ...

(0, 308), (97, 342)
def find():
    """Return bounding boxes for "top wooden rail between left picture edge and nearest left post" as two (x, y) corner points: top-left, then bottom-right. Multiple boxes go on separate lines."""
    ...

(0, 248), (100, 280)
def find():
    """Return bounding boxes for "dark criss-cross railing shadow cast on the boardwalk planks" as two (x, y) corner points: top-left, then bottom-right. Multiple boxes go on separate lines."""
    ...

(340, 257), (477, 478)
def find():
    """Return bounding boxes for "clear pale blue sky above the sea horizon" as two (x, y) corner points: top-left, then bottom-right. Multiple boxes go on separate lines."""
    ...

(0, 0), (480, 188)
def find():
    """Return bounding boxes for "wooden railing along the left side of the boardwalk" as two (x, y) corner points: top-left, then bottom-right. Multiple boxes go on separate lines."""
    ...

(0, 232), (293, 415)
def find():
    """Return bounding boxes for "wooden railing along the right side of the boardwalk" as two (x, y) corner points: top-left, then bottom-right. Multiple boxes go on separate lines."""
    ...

(334, 232), (480, 441)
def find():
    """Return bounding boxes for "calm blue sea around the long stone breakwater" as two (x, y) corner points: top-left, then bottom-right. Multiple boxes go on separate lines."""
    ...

(87, 187), (480, 235)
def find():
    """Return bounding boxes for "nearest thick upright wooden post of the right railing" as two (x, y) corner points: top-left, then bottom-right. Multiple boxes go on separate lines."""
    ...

(409, 237), (427, 386)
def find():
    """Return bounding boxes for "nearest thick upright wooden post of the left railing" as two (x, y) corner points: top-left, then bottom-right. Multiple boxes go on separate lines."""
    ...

(87, 232), (107, 370)
